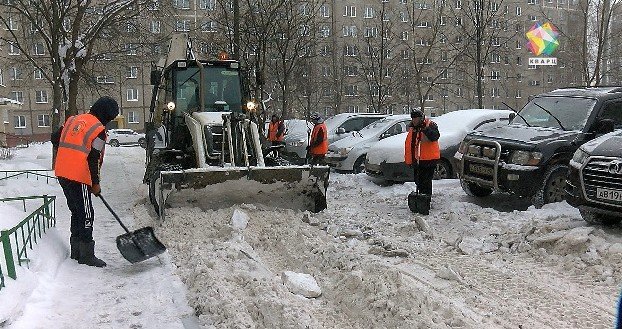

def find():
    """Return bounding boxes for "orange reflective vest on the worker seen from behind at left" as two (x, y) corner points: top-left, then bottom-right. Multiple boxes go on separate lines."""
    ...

(54, 113), (105, 186)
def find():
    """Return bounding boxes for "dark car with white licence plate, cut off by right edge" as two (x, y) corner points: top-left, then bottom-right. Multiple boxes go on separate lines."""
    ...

(565, 129), (622, 225)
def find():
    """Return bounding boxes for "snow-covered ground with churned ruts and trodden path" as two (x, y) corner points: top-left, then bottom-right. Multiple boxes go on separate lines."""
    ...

(0, 144), (622, 328)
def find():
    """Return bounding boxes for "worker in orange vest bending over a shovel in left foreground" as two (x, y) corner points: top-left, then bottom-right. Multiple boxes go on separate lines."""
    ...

(52, 96), (119, 267)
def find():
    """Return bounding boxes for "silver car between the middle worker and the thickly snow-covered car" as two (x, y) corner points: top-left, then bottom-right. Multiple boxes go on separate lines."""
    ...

(325, 114), (411, 173)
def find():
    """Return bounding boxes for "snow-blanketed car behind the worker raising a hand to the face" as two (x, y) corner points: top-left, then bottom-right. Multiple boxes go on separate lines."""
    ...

(365, 109), (514, 182)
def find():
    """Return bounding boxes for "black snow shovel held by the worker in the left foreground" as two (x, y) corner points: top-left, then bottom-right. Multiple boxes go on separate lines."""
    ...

(99, 194), (166, 264)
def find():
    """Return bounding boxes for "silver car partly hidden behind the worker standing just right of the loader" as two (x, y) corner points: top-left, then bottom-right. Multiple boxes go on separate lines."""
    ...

(281, 113), (388, 163)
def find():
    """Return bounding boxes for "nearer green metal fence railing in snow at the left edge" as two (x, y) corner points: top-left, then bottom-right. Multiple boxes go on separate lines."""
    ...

(0, 195), (56, 289)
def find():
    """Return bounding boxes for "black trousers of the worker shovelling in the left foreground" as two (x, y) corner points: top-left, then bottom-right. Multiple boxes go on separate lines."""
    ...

(58, 177), (94, 242)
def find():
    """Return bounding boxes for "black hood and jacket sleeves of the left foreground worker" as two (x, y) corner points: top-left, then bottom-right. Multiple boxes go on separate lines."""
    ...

(51, 96), (119, 184)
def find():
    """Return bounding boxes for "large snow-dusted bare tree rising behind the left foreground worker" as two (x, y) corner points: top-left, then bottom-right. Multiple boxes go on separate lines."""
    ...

(0, 0), (149, 129)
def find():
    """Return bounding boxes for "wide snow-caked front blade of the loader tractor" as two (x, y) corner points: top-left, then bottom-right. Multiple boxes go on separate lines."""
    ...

(158, 166), (329, 217)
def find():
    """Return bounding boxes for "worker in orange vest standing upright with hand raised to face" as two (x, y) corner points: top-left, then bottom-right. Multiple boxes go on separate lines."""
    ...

(404, 109), (441, 215)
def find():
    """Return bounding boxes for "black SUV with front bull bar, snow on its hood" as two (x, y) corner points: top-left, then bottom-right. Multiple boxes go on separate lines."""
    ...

(455, 87), (622, 207)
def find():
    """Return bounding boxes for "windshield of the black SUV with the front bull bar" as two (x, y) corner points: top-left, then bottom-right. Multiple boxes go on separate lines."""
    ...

(512, 96), (596, 130)
